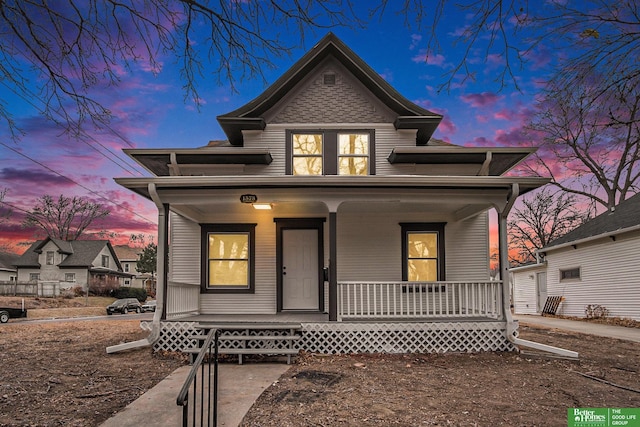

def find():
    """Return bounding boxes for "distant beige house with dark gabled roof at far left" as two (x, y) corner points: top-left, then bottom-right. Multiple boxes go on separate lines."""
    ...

(14, 237), (133, 296)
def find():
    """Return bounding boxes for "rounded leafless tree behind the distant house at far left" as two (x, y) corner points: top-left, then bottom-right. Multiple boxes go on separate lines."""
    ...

(23, 195), (109, 241)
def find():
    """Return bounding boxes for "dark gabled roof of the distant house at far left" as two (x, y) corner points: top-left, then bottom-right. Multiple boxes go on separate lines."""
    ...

(14, 237), (121, 270)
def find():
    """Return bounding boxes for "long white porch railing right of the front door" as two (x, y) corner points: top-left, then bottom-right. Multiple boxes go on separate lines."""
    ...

(338, 281), (502, 321)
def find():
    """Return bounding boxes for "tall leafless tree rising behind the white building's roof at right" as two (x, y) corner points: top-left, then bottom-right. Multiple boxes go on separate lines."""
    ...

(527, 74), (640, 209)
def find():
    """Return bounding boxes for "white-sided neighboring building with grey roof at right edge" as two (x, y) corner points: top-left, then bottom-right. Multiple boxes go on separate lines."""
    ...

(511, 194), (640, 320)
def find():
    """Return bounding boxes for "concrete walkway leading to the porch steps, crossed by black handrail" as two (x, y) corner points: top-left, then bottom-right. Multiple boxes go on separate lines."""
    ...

(101, 363), (290, 427)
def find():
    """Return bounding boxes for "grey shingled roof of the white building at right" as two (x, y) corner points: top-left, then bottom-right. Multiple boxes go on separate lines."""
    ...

(539, 193), (640, 252)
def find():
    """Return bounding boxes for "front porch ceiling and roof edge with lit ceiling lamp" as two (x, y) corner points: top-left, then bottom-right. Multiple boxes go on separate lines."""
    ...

(116, 176), (548, 221)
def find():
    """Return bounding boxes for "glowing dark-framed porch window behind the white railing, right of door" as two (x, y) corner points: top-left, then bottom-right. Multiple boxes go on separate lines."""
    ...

(400, 223), (445, 282)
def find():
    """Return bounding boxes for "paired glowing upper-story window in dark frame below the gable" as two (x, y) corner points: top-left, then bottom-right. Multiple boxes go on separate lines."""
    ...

(286, 130), (375, 175)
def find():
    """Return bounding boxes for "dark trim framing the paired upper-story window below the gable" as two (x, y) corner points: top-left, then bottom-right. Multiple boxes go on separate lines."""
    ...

(285, 128), (376, 176)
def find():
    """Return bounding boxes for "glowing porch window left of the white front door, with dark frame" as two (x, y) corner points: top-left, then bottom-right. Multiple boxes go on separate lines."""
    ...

(201, 224), (256, 293)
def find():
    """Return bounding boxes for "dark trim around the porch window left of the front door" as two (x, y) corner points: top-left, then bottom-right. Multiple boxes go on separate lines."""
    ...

(200, 224), (258, 294)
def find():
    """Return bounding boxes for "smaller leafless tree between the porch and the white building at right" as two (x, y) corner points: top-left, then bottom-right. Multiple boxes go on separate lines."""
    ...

(507, 187), (593, 265)
